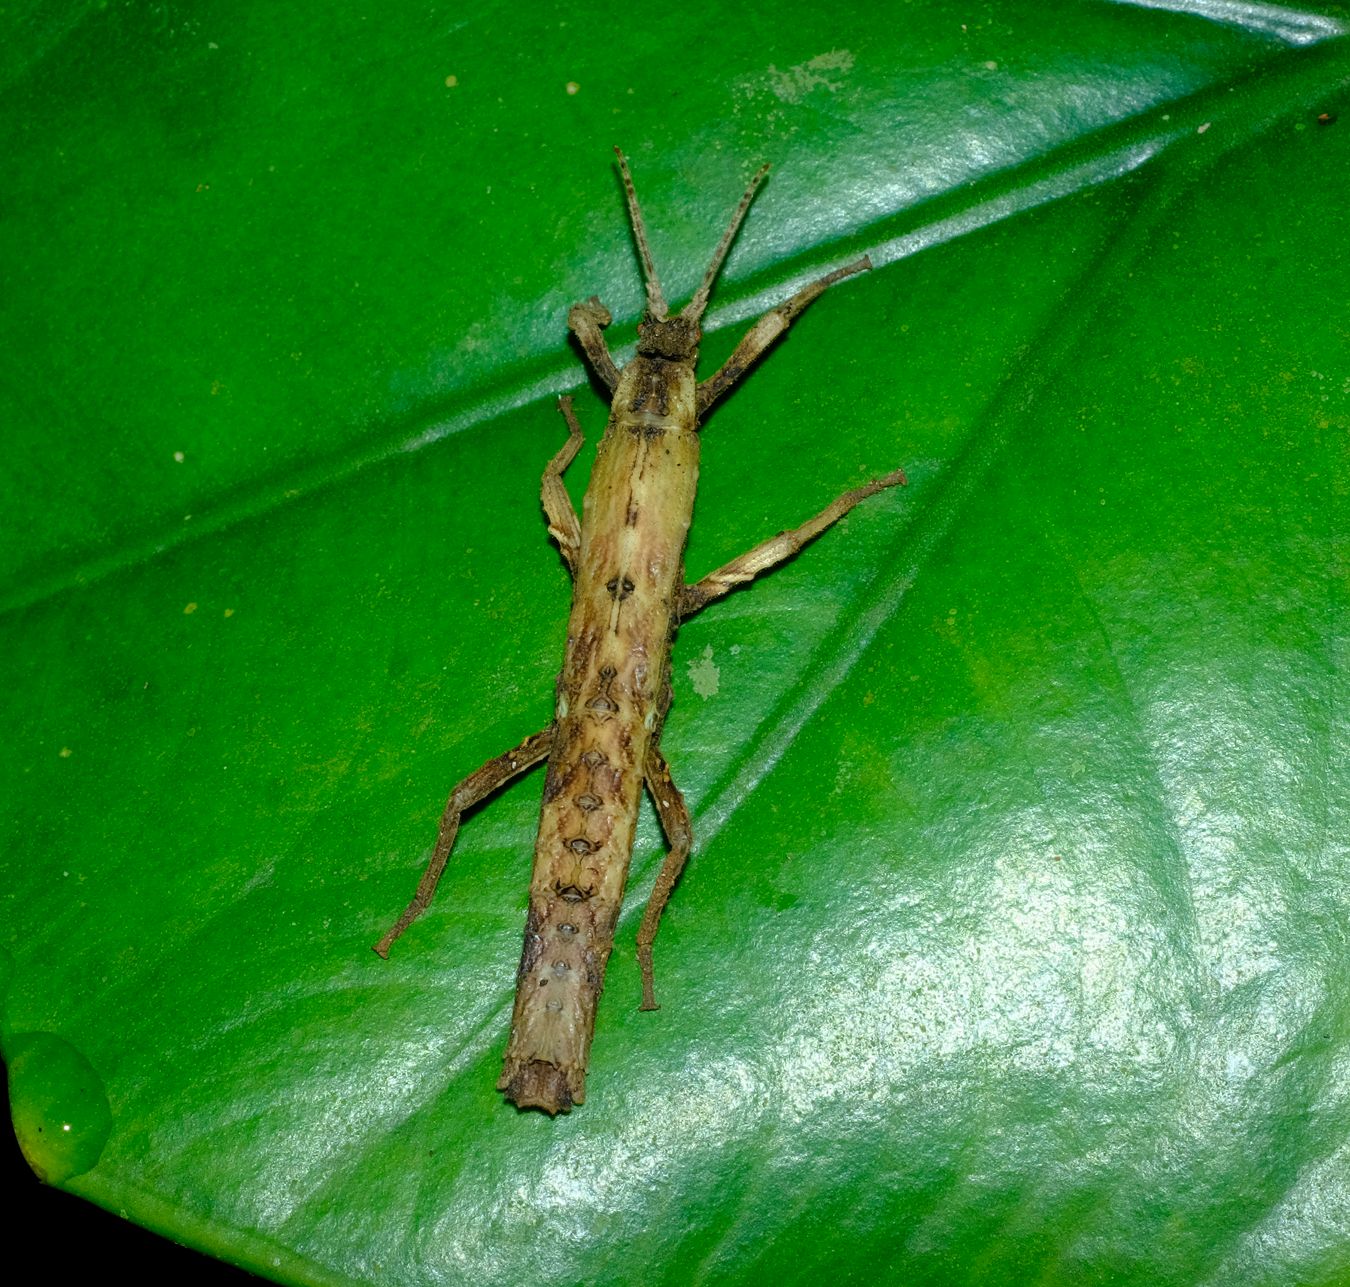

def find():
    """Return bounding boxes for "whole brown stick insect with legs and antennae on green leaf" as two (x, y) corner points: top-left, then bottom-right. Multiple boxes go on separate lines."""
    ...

(375, 147), (906, 1114)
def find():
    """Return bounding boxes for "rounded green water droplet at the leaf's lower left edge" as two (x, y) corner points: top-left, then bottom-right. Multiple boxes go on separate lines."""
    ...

(5, 1032), (112, 1184)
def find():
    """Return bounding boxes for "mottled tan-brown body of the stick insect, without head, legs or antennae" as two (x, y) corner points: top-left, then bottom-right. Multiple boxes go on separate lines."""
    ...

(498, 357), (698, 1111)
